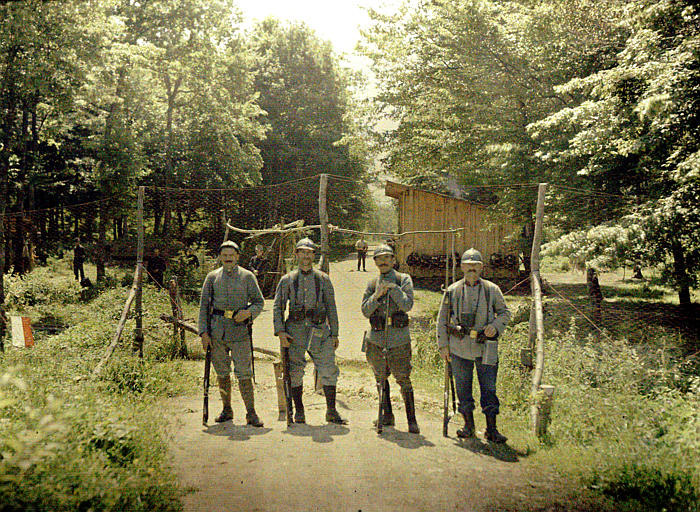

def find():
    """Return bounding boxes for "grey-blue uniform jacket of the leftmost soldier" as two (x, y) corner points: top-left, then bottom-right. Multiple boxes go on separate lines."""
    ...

(198, 266), (265, 341)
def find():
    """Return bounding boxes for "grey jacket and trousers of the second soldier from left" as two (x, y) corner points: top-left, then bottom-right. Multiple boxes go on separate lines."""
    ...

(273, 270), (340, 387)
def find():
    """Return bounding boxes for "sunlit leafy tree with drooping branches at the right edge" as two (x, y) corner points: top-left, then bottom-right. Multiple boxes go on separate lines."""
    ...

(532, 0), (700, 305)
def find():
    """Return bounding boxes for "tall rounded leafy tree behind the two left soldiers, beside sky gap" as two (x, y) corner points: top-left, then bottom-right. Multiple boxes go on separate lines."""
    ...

(250, 18), (367, 230)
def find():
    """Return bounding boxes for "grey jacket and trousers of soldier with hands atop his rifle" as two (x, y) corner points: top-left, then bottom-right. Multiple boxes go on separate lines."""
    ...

(362, 269), (413, 390)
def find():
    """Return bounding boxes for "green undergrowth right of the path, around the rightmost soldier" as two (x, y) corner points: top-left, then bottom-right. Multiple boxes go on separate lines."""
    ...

(412, 293), (700, 511)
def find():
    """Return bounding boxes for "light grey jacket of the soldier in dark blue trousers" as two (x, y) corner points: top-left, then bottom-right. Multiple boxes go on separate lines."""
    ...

(437, 278), (510, 360)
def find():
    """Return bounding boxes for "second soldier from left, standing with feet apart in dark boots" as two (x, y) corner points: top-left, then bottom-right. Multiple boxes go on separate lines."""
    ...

(273, 238), (347, 425)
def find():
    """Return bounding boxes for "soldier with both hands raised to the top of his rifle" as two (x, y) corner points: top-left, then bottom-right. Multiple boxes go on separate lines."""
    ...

(362, 245), (420, 434)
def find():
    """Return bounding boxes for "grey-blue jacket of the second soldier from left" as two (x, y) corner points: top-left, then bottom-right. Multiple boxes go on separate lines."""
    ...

(272, 269), (338, 338)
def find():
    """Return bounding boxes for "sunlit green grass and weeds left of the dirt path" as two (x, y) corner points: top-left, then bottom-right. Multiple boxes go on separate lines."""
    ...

(0, 260), (197, 511)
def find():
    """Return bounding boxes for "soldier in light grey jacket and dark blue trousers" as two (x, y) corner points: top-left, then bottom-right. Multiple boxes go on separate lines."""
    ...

(437, 249), (510, 443)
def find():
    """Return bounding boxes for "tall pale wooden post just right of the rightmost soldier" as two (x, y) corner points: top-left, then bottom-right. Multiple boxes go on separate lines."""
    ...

(530, 183), (554, 437)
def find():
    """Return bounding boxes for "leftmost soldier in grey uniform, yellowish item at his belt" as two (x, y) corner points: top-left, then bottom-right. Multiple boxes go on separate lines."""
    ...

(199, 241), (264, 427)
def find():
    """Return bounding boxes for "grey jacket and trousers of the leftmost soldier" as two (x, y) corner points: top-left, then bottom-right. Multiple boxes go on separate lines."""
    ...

(198, 266), (264, 380)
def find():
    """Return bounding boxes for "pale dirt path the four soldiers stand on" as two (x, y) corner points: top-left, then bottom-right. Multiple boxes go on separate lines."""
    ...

(164, 260), (604, 512)
